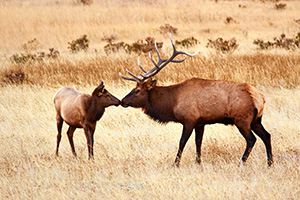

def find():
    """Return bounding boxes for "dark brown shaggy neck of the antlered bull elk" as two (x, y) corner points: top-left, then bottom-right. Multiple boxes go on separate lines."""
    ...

(143, 86), (177, 123)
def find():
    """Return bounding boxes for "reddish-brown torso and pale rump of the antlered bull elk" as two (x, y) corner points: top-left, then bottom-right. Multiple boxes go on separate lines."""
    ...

(174, 78), (264, 124)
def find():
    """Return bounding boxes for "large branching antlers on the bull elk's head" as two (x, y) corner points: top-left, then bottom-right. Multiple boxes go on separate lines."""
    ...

(119, 33), (199, 83)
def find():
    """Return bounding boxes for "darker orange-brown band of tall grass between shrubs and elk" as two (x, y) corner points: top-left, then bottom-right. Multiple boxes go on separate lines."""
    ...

(0, 51), (300, 88)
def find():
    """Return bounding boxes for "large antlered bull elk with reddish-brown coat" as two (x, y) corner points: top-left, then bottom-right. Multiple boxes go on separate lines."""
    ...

(120, 35), (273, 166)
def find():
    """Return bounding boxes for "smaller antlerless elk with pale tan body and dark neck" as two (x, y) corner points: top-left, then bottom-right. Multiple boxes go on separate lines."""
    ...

(54, 82), (120, 159)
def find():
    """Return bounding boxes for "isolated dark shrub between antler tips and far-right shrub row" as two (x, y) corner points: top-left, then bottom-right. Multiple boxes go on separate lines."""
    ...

(206, 38), (239, 53)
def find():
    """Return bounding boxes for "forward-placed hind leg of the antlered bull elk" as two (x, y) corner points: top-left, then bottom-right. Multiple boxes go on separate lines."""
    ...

(236, 123), (256, 166)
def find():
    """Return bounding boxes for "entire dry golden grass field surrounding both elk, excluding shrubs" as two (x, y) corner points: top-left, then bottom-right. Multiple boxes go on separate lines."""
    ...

(0, 0), (300, 199)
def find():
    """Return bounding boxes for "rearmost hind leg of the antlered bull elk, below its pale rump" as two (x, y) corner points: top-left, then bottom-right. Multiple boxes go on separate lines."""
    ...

(251, 117), (273, 166)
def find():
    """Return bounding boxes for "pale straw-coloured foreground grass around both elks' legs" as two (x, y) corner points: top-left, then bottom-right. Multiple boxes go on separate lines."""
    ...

(0, 86), (300, 199)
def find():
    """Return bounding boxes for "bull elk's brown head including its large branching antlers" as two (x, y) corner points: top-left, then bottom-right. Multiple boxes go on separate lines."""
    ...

(119, 34), (198, 108)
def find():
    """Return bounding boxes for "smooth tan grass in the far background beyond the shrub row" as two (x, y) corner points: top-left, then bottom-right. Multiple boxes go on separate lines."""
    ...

(0, 0), (300, 55)
